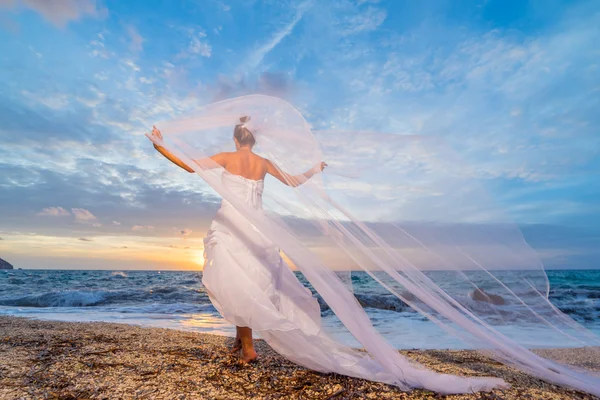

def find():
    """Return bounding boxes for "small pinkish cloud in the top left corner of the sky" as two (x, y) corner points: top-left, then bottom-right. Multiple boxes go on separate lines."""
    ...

(0, 0), (106, 27)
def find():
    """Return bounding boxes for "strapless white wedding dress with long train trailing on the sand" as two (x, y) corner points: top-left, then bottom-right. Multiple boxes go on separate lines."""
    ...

(202, 172), (507, 393)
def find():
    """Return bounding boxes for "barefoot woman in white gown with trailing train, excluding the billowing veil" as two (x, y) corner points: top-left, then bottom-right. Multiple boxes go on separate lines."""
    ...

(148, 110), (506, 393)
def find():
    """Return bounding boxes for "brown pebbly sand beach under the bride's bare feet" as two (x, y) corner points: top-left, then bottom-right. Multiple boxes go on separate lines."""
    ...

(0, 316), (600, 400)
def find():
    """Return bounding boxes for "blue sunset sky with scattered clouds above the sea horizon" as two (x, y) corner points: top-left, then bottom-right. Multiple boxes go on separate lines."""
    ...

(0, 0), (600, 269)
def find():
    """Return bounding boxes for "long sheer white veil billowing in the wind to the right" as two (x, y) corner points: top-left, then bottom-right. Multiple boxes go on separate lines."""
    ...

(149, 95), (600, 395)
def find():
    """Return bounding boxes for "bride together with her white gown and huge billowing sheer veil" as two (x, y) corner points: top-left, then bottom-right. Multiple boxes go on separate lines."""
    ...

(147, 95), (600, 395)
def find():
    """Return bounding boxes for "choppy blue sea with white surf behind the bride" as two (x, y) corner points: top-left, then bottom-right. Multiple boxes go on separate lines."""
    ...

(0, 270), (600, 349)
